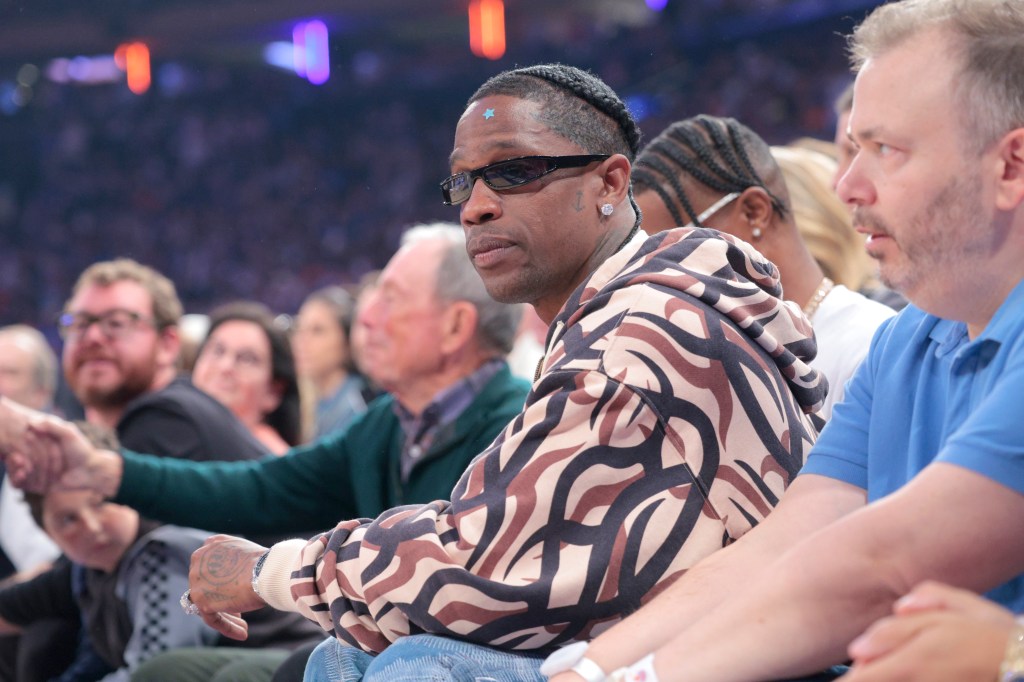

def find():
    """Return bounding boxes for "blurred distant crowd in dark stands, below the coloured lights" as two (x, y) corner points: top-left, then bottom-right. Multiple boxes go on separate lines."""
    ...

(0, 8), (849, 333)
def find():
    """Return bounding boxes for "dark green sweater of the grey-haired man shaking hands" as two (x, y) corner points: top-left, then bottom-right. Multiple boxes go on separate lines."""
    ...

(114, 367), (527, 536)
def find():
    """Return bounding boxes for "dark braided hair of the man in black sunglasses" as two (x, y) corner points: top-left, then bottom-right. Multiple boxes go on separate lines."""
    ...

(467, 63), (641, 225)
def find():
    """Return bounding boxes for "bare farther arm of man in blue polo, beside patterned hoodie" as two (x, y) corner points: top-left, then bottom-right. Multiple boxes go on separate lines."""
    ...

(552, 475), (865, 682)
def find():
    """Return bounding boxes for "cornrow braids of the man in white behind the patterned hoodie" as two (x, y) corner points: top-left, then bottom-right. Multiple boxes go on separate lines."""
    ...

(633, 115), (788, 227)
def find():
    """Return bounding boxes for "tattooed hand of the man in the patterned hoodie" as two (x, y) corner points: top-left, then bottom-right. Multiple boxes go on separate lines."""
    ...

(188, 536), (266, 639)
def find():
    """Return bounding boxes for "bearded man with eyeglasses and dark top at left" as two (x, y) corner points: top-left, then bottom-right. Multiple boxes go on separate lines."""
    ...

(57, 259), (267, 460)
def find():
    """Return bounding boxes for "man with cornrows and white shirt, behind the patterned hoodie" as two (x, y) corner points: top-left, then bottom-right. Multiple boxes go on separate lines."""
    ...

(633, 115), (893, 420)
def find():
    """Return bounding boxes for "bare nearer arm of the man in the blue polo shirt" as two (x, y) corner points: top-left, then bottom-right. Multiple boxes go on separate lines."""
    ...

(654, 463), (1024, 682)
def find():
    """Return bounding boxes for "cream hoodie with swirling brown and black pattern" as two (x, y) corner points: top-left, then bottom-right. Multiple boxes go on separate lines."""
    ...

(263, 229), (824, 651)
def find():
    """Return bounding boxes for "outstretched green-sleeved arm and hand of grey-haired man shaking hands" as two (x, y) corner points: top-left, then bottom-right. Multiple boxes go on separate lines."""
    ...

(11, 411), (354, 534)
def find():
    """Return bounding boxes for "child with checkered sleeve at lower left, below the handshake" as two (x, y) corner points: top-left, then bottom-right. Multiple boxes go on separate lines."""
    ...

(0, 423), (217, 682)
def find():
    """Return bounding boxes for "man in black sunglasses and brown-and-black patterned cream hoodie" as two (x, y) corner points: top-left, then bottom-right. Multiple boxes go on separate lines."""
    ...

(0, 65), (825, 681)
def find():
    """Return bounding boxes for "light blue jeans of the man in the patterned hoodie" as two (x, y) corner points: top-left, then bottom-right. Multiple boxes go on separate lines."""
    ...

(302, 635), (546, 682)
